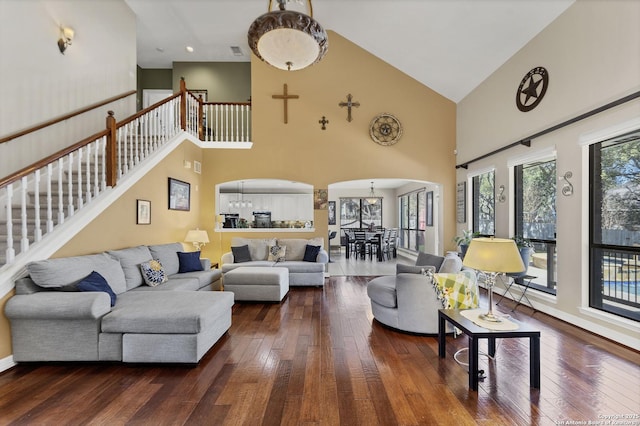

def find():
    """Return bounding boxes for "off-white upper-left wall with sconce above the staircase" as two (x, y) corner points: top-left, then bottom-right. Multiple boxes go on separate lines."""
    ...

(0, 0), (136, 177)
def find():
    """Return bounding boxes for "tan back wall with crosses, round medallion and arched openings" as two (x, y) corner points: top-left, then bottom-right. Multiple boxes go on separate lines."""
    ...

(201, 31), (456, 258)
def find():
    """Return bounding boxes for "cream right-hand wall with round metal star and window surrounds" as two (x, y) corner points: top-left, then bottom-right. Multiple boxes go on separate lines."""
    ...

(457, 0), (640, 349)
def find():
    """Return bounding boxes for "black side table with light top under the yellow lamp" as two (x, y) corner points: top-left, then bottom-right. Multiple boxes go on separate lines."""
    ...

(438, 309), (540, 391)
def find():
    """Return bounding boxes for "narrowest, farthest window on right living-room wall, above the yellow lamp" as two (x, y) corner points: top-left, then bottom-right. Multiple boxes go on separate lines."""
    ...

(471, 170), (496, 236)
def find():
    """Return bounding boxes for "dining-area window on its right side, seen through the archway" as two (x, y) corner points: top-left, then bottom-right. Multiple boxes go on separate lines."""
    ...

(398, 189), (427, 252)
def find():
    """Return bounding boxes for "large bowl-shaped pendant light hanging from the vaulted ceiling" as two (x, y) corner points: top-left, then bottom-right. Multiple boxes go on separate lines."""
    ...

(247, 0), (329, 71)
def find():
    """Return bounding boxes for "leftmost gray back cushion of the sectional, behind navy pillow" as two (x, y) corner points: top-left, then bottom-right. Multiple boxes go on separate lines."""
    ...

(27, 253), (127, 294)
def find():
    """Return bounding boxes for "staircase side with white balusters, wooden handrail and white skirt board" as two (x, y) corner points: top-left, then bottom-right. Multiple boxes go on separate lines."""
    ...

(0, 81), (252, 297)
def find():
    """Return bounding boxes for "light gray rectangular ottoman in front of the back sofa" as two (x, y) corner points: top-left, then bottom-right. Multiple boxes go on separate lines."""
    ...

(222, 266), (289, 302)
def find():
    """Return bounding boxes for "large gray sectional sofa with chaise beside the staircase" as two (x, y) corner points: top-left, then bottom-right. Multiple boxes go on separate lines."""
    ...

(5, 243), (234, 363)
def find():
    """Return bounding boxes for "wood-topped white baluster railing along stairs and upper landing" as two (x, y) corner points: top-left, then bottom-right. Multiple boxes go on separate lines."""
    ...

(0, 80), (251, 269)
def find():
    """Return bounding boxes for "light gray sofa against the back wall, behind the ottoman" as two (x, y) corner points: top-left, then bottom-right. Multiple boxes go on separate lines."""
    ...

(221, 237), (329, 286)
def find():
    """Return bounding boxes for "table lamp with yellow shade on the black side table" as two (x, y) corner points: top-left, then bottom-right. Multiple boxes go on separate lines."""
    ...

(462, 238), (525, 322)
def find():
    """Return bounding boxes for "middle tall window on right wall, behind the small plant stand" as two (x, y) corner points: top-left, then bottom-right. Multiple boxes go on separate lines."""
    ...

(514, 158), (557, 294)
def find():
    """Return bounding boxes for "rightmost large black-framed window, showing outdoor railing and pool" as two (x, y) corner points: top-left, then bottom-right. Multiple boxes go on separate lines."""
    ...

(589, 131), (640, 321)
